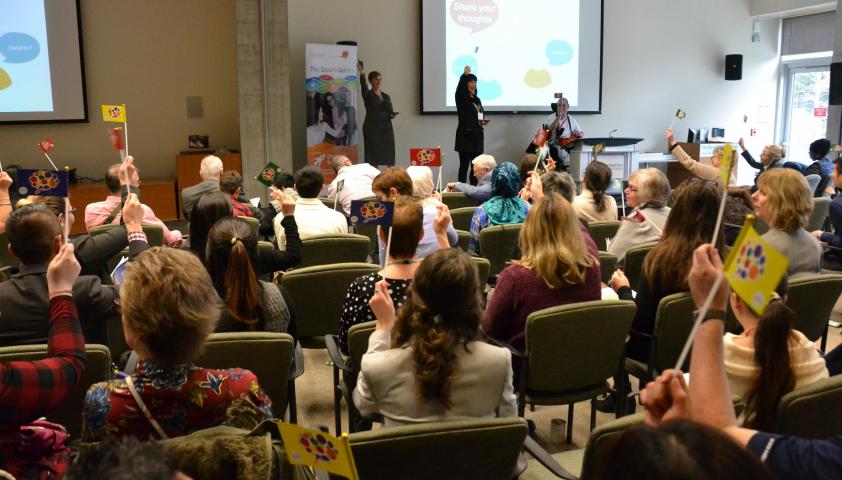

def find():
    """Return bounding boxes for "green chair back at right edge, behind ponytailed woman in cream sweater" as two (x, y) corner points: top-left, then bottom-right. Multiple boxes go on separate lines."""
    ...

(775, 375), (842, 439)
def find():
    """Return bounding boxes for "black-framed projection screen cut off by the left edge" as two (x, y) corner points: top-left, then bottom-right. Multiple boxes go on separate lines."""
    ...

(0, 0), (88, 123)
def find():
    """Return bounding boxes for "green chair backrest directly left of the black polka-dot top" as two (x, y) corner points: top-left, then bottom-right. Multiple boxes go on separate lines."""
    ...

(281, 263), (380, 348)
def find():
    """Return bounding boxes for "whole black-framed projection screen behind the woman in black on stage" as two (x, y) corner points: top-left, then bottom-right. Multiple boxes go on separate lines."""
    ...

(421, 0), (603, 113)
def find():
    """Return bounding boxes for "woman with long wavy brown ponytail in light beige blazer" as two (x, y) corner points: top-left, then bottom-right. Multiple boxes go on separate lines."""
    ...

(354, 249), (517, 427)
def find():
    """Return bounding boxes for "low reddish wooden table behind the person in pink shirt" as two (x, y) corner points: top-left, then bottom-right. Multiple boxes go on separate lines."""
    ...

(70, 178), (178, 235)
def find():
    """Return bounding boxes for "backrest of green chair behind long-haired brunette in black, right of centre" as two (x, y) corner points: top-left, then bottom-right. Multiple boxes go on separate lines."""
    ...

(649, 292), (696, 372)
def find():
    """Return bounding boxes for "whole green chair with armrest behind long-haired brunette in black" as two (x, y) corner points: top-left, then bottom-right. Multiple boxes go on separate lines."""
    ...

(626, 292), (696, 382)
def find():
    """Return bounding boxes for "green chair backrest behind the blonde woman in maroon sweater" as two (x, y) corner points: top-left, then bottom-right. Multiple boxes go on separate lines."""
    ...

(525, 300), (637, 392)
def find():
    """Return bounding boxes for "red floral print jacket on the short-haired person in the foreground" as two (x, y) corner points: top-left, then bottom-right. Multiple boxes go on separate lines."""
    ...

(82, 362), (272, 442)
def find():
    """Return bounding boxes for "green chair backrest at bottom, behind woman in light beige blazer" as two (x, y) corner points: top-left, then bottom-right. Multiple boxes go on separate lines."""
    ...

(350, 417), (527, 480)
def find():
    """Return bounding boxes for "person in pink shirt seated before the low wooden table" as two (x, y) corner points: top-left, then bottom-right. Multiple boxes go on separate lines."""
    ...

(85, 163), (181, 247)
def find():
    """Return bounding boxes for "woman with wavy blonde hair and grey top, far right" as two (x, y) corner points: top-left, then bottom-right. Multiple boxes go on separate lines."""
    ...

(751, 168), (822, 276)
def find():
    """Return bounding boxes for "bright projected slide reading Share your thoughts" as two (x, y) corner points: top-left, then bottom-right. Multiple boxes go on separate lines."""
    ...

(445, 0), (579, 107)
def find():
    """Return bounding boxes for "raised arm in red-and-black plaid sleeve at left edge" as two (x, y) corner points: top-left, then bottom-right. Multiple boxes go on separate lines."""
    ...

(0, 244), (87, 427)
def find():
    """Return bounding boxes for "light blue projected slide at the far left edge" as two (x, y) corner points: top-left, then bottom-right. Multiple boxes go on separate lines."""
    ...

(0, 0), (53, 112)
